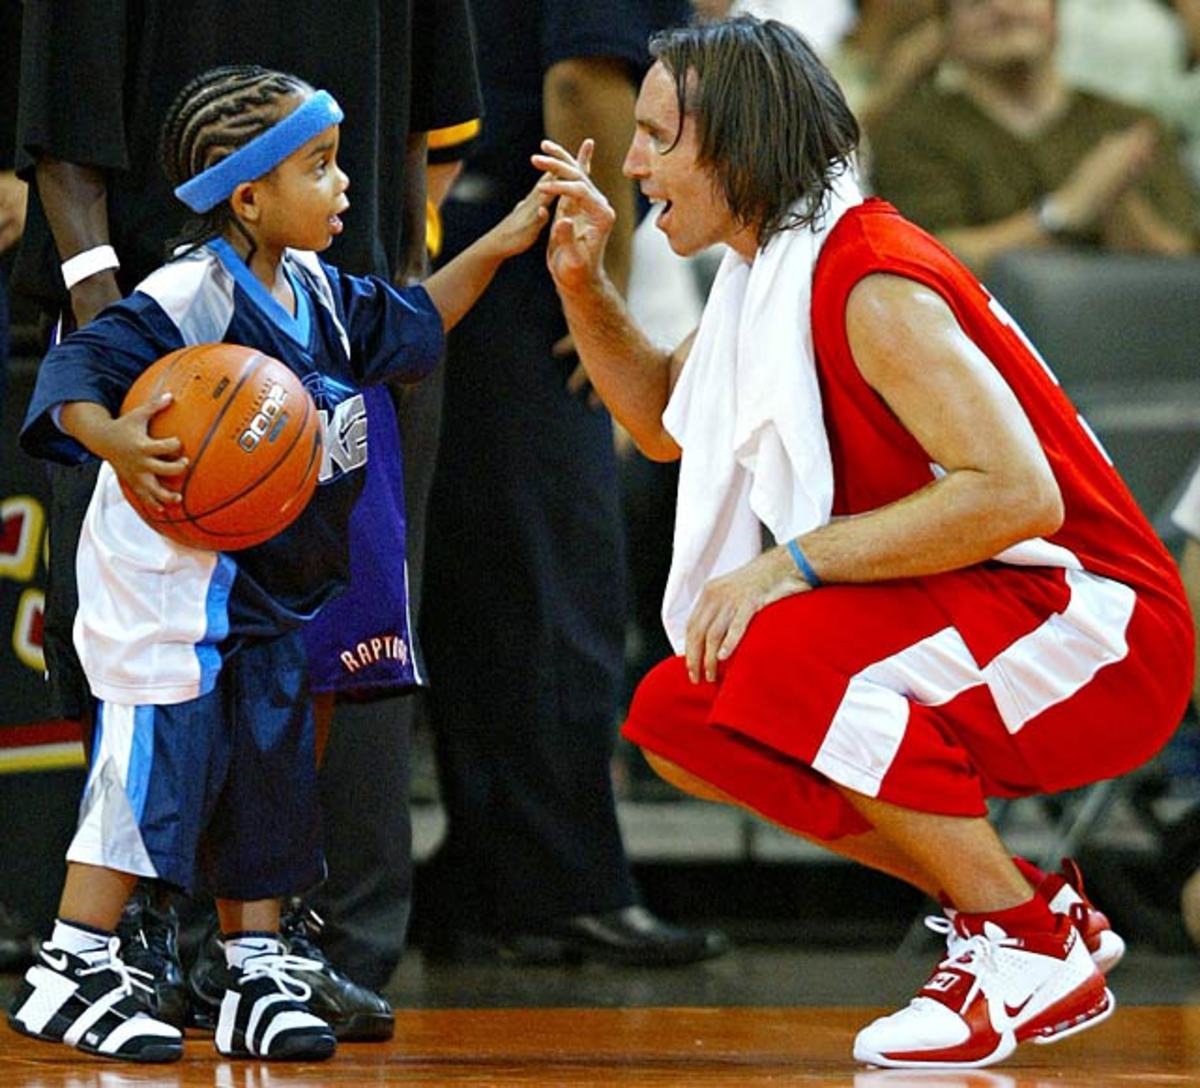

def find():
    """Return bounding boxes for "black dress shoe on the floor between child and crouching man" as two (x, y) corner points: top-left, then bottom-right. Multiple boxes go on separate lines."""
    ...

(500, 904), (730, 967)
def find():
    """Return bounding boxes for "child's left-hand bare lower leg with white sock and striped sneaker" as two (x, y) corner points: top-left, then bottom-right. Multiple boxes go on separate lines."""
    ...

(8, 862), (184, 1062)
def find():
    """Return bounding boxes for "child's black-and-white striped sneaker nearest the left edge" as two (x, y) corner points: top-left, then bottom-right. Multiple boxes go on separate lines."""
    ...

(8, 937), (184, 1062)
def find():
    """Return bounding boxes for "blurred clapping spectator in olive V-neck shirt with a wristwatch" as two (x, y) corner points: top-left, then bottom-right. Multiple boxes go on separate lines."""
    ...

(872, 0), (1198, 276)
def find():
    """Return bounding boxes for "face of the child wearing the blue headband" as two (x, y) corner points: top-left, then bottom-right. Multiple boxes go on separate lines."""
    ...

(254, 112), (350, 252)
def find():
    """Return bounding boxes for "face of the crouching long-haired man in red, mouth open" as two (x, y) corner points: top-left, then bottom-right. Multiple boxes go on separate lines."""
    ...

(624, 64), (738, 257)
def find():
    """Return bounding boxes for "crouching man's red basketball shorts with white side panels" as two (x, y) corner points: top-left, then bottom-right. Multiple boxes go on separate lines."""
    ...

(623, 564), (1193, 840)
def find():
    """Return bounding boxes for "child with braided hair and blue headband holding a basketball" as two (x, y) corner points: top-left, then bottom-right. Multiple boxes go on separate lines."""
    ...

(8, 66), (548, 1062)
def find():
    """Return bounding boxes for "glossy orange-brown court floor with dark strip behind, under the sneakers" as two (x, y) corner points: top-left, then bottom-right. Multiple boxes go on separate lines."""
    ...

(0, 945), (1200, 1088)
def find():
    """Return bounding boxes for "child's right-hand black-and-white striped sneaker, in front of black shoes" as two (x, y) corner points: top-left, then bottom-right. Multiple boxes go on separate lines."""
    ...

(212, 937), (337, 1062)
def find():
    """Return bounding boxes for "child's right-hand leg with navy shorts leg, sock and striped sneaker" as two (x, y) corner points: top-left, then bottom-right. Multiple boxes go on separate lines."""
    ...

(187, 632), (350, 1059)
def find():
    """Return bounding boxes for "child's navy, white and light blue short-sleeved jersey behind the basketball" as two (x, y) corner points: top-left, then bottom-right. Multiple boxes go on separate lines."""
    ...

(22, 241), (444, 703)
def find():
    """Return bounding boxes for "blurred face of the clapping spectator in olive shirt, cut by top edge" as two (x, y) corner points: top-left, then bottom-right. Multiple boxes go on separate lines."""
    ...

(946, 0), (1055, 72)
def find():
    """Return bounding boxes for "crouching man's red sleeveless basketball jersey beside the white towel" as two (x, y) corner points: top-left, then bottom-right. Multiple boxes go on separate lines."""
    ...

(812, 199), (1182, 618)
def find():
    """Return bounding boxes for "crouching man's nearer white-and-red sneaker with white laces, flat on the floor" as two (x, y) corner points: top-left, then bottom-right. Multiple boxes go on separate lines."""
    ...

(854, 915), (1116, 1069)
